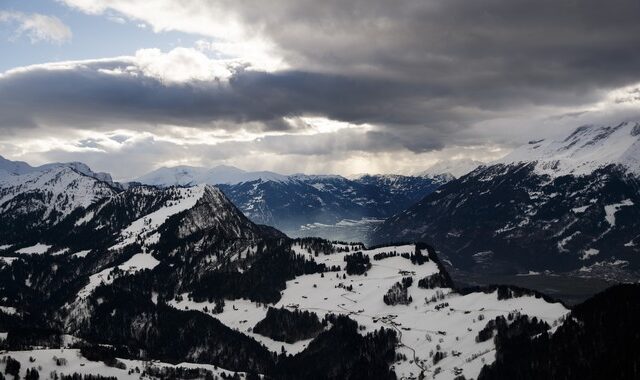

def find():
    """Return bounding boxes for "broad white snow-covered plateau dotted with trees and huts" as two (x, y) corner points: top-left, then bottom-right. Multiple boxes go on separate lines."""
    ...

(172, 245), (568, 379)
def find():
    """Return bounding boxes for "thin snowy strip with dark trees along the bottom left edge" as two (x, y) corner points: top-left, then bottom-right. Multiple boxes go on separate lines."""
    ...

(0, 348), (246, 380)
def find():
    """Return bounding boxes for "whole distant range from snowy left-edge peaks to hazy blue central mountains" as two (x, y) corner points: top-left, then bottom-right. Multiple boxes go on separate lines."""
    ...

(0, 154), (478, 241)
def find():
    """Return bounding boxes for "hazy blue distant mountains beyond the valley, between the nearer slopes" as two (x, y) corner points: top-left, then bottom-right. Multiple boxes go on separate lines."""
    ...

(134, 166), (451, 241)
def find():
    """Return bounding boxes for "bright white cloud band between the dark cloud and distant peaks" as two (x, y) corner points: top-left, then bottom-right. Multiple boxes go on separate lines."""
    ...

(0, 123), (500, 180)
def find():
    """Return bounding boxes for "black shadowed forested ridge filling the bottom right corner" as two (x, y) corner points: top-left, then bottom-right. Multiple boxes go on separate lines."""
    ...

(478, 284), (640, 380)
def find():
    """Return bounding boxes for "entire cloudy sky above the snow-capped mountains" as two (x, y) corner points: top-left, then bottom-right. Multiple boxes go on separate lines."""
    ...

(0, 0), (640, 179)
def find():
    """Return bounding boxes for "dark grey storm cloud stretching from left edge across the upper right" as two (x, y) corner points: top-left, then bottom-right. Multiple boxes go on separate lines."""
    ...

(6, 0), (640, 152)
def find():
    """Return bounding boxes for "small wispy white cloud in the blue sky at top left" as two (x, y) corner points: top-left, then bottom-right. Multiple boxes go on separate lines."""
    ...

(0, 11), (73, 44)
